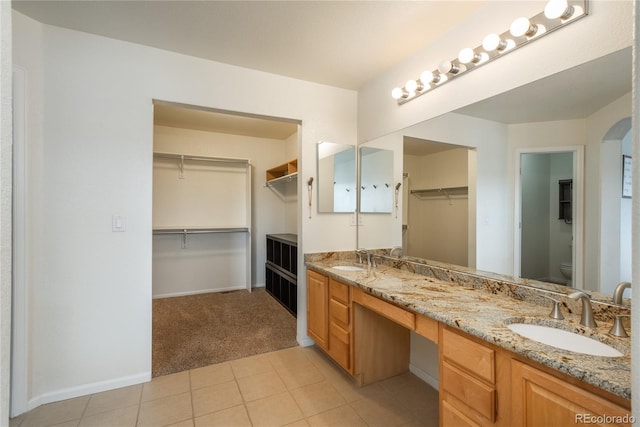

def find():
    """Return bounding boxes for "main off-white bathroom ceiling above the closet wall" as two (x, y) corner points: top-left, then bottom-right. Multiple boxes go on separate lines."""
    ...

(13, 0), (489, 90)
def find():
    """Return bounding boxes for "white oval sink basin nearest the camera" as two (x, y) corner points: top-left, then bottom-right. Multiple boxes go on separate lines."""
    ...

(507, 323), (623, 357)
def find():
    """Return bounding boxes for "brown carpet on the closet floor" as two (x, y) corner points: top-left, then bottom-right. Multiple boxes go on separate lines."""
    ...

(152, 288), (298, 377)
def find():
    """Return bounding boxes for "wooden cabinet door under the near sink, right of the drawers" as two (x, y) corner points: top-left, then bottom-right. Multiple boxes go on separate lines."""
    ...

(511, 360), (631, 427)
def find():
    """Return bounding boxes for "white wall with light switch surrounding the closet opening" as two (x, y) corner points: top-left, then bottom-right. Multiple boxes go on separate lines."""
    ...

(13, 13), (356, 414)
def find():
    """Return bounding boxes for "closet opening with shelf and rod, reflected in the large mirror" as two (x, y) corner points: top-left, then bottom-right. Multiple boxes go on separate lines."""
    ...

(403, 137), (476, 267)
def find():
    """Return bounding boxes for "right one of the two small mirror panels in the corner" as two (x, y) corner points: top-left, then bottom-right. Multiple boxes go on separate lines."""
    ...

(360, 147), (395, 213)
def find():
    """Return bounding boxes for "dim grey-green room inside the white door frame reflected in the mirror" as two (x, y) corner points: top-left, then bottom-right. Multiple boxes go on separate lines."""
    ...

(520, 152), (575, 286)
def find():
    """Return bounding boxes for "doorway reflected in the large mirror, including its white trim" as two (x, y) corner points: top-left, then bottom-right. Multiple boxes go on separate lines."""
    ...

(514, 147), (583, 288)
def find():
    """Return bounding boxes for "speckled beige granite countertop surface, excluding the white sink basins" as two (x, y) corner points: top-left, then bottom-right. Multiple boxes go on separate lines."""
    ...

(306, 259), (631, 399)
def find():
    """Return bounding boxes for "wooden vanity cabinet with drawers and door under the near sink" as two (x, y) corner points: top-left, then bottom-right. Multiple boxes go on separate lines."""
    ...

(439, 324), (630, 427)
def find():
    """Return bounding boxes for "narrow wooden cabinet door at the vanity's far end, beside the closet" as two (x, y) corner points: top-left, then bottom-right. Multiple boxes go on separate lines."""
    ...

(307, 270), (329, 350)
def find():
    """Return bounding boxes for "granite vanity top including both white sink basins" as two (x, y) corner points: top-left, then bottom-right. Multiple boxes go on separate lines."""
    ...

(320, 257), (631, 399)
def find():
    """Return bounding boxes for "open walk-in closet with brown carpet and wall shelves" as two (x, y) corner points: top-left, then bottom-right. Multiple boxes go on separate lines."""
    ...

(152, 101), (299, 376)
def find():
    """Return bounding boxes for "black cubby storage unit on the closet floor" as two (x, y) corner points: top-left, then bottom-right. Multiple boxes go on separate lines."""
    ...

(265, 234), (298, 317)
